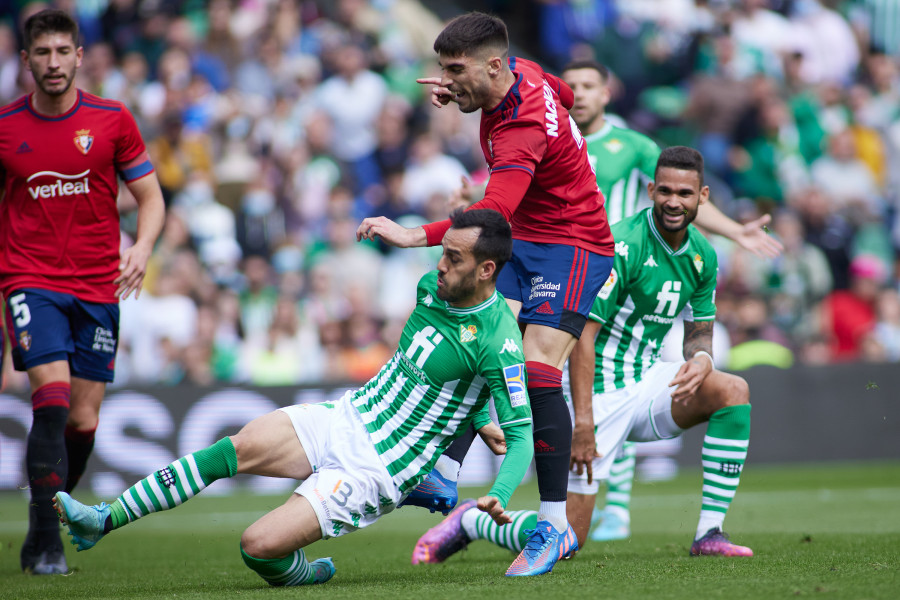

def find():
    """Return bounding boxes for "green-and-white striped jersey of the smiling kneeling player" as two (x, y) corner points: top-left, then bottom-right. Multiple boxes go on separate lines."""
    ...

(589, 208), (718, 393)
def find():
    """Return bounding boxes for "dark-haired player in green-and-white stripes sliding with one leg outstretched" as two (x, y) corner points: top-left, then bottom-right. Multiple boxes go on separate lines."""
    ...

(54, 210), (533, 586)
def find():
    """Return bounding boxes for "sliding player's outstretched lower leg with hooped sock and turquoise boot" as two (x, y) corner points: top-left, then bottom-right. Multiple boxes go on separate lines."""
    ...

(54, 437), (237, 551)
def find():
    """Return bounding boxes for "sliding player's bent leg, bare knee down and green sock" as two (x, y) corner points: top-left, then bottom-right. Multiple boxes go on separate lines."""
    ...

(241, 494), (335, 586)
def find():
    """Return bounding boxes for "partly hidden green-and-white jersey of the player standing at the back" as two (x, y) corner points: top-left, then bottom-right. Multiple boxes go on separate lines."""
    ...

(584, 121), (660, 225)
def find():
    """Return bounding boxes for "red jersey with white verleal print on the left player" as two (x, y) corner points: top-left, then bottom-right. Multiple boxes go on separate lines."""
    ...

(0, 90), (153, 302)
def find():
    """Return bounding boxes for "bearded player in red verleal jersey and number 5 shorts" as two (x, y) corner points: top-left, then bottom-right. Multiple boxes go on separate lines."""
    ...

(0, 10), (165, 575)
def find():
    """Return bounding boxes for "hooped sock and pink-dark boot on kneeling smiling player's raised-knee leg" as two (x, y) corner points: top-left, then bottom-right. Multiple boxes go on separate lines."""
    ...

(691, 404), (753, 556)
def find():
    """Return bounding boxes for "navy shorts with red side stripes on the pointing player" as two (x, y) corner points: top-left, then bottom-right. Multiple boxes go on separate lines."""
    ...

(497, 240), (613, 338)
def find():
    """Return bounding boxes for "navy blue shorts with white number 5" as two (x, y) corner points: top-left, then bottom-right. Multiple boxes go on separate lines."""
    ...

(6, 288), (119, 383)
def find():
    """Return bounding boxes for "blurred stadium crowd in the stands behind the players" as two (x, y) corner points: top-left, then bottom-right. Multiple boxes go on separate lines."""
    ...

(0, 0), (900, 390)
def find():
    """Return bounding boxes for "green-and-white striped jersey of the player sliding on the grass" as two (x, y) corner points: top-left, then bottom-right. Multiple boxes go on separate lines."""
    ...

(350, 271), (531, 493)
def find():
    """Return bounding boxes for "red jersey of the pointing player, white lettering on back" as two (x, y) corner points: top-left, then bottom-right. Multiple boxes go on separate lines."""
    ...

(480, 57), (613, 256)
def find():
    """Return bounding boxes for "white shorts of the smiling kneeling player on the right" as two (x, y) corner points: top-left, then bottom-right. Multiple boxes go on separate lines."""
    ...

(568, 361), (684, 495)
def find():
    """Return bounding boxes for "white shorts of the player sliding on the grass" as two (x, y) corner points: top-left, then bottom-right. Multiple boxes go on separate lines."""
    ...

(280, 399), (400, 539)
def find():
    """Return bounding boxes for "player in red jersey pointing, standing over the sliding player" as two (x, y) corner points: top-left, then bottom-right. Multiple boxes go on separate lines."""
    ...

(357, 12), (613, 576)
